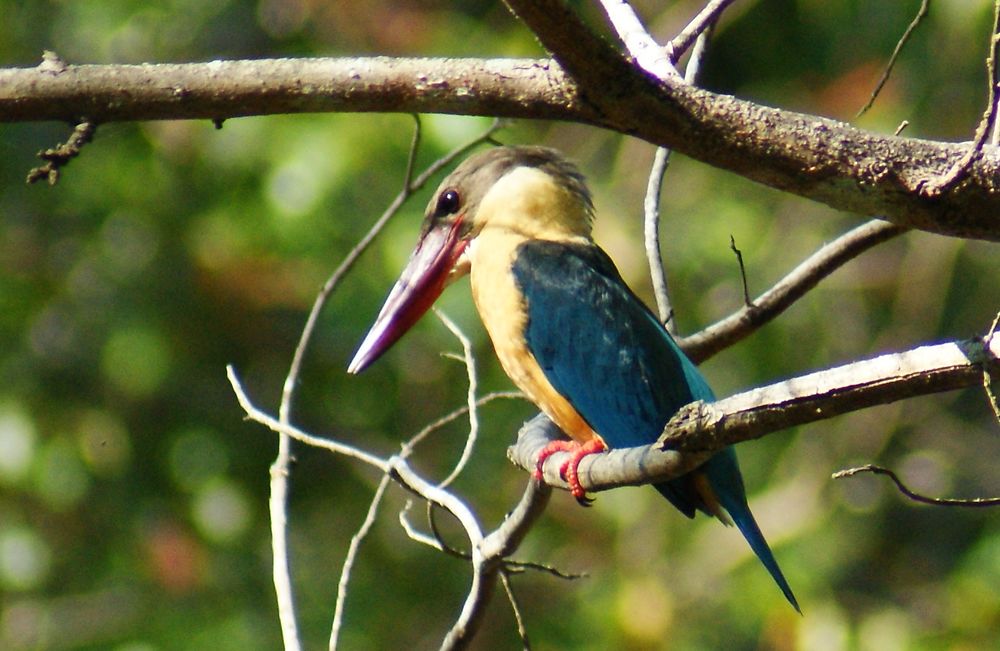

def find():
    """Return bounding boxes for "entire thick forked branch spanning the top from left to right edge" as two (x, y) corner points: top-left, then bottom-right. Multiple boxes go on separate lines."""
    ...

(0, 47), (1000, 241)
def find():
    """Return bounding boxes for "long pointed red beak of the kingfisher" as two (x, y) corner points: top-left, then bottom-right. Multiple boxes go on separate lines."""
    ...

(347, 218), (468, 373)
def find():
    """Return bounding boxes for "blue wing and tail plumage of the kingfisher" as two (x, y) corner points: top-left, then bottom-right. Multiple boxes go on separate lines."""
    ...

(512, 240), (798, 610)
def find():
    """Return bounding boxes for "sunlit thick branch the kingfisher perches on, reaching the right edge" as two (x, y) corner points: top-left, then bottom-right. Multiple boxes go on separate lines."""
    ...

(507, 336), (1000, 491)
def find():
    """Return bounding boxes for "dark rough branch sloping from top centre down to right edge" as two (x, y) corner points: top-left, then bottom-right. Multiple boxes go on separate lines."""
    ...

(507, 0), (1000, 240)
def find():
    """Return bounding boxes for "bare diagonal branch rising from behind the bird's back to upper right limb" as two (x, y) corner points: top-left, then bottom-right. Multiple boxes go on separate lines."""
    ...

(677, 219), (907, 363)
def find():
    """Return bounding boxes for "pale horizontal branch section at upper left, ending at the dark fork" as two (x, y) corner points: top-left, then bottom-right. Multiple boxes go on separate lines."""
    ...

(0, 57), (598, 123)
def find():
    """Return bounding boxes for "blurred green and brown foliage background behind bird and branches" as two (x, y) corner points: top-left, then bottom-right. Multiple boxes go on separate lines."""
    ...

(0, 0), (1000, 651)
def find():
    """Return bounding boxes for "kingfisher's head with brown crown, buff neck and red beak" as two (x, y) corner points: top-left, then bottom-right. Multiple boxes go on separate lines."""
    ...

(348, 146), (593, 373)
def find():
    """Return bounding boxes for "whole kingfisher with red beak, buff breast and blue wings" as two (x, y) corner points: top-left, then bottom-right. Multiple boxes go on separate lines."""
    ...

(348, 145), (801, 613)
